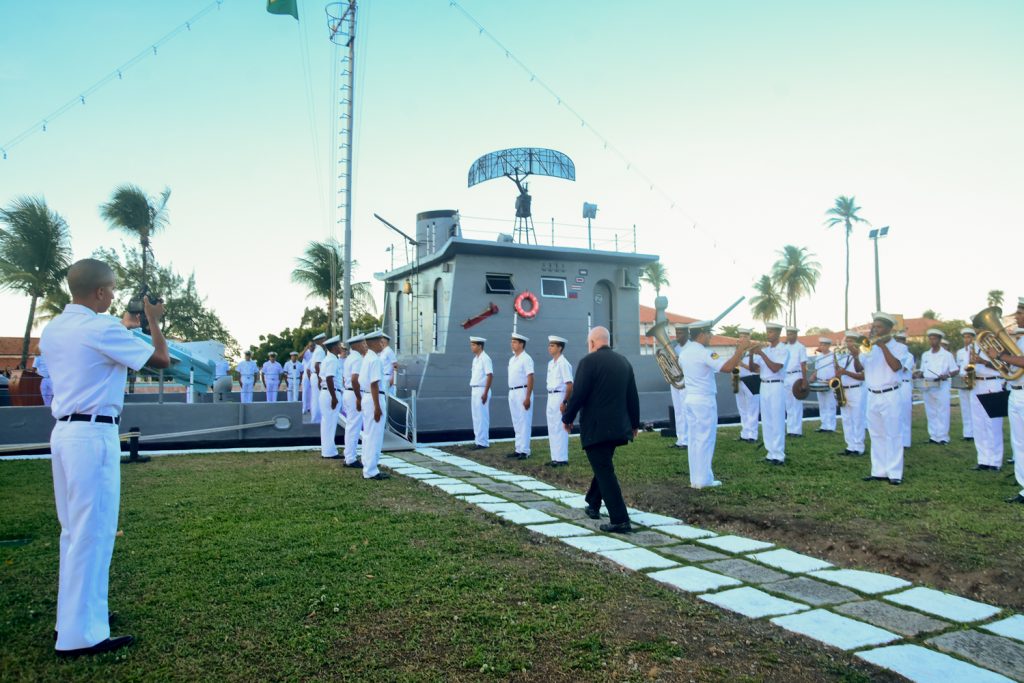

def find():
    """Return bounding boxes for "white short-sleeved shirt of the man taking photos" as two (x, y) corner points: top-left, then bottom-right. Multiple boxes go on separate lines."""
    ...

(39, 303), (153, 418)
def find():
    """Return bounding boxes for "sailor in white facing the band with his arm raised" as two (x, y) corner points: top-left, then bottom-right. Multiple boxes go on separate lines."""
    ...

(679, 321), (751, 488)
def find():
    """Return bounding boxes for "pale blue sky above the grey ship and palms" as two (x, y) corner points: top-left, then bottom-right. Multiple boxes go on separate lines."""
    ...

(0, 0), (1024, 352)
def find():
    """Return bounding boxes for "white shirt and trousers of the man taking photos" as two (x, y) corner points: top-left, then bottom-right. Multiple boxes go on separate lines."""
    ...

(39, 304), (153, 650)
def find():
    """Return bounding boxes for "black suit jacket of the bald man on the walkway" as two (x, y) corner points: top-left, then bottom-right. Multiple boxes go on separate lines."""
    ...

(562, 346), (640, 449)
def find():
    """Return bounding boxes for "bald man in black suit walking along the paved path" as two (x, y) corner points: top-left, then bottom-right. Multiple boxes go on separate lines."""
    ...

(562, 328), (640, 533)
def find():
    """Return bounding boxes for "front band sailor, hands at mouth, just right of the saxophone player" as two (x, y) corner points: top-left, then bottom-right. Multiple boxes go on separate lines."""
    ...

(854, 311), (903, 485)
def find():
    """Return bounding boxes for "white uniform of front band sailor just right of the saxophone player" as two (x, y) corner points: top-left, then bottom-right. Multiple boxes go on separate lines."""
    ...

(860, 340), (906, 480)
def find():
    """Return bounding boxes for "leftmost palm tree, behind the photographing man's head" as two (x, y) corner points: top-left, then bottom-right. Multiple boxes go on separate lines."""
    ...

(0, 197), (72, 368)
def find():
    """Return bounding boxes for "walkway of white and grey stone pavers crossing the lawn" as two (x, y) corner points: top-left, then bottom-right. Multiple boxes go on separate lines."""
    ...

(381, 447), (1024, 683)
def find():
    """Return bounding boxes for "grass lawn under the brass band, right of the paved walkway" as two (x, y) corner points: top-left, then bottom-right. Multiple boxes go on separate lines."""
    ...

(456, 407), (1024, 609)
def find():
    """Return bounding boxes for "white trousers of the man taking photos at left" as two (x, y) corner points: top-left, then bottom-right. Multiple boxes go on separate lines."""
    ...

(50, 422), (121, 650)
